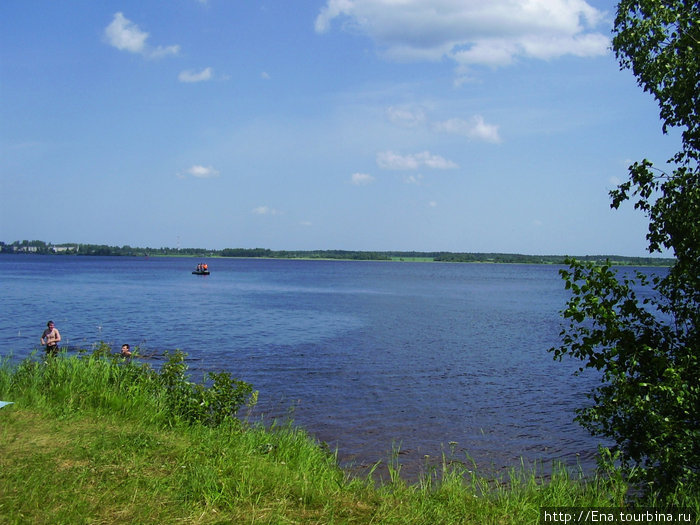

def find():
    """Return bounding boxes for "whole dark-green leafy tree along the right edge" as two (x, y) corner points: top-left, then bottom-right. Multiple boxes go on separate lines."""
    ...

(552, 0), (700, 502)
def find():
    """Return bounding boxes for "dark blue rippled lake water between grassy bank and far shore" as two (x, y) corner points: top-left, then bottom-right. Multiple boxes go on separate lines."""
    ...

(0, 255), (658, 477)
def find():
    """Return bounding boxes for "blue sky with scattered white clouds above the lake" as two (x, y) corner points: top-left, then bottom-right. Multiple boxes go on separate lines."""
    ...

(0, 0), (678, 256)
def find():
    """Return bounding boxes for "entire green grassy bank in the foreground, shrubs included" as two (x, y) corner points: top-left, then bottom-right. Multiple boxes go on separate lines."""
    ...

(0, 348), (692, 524)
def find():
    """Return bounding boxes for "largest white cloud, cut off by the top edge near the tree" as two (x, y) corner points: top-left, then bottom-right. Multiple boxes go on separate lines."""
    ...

(315, 0), (610, 68)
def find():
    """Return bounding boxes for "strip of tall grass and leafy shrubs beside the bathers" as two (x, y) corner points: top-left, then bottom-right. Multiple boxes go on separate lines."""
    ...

(0, 343), (257, 427)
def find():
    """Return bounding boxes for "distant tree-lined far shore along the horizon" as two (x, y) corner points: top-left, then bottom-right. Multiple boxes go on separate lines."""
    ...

(0, 240), (674, 266)
